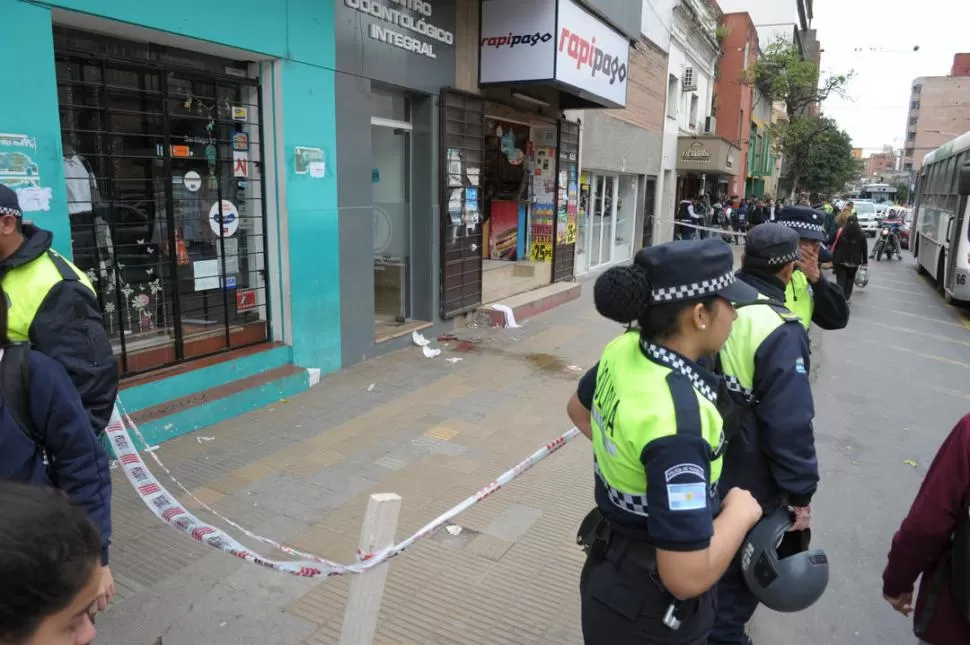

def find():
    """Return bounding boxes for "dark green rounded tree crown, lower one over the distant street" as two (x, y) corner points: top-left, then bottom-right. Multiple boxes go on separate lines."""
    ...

(796, 117), (862, 195)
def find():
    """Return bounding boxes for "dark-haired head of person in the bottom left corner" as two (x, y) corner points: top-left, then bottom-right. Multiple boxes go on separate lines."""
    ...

(0, 480), (101, 645)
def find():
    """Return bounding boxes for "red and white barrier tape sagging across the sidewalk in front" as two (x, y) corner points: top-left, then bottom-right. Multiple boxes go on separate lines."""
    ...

(105, 400), (580, 578)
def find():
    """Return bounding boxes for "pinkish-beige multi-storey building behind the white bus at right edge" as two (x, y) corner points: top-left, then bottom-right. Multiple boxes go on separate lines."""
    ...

(903, 54), (970, 172)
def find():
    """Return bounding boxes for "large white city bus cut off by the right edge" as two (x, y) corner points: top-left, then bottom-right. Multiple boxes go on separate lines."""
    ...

(911, 132), (970, 302)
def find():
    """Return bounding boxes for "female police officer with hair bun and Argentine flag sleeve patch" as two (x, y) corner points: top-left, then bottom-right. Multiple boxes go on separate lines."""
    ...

(568, 239), (761, 645)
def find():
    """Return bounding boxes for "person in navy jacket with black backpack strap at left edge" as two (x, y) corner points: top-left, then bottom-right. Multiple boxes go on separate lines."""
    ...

(0, 290), (115, 612)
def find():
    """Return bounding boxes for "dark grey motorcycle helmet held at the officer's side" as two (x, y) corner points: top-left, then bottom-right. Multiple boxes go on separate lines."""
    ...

(741, 509), (829, 613)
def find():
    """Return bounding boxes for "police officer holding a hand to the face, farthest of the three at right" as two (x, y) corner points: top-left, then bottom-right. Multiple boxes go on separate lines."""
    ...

(776, 206), (849, 330)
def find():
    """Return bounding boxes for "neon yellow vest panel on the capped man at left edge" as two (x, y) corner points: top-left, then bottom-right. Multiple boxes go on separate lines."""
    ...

(0, 251), (94, 342)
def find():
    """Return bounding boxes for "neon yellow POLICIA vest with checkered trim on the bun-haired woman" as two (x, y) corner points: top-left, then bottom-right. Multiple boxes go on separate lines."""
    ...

(590, 332), (723, 516)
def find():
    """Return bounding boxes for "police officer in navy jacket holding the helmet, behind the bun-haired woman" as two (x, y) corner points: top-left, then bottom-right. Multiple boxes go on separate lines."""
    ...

(708, 223), (819, 645)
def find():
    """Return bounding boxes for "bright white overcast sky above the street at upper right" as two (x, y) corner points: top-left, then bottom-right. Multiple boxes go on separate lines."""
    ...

(812, 0), (970, 154)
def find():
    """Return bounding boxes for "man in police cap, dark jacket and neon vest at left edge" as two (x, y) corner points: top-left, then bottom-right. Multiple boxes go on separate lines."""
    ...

(0, 184), (118, 434)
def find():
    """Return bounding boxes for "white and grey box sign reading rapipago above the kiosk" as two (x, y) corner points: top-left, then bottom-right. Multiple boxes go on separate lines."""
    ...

(478, 0), (630, 107)
